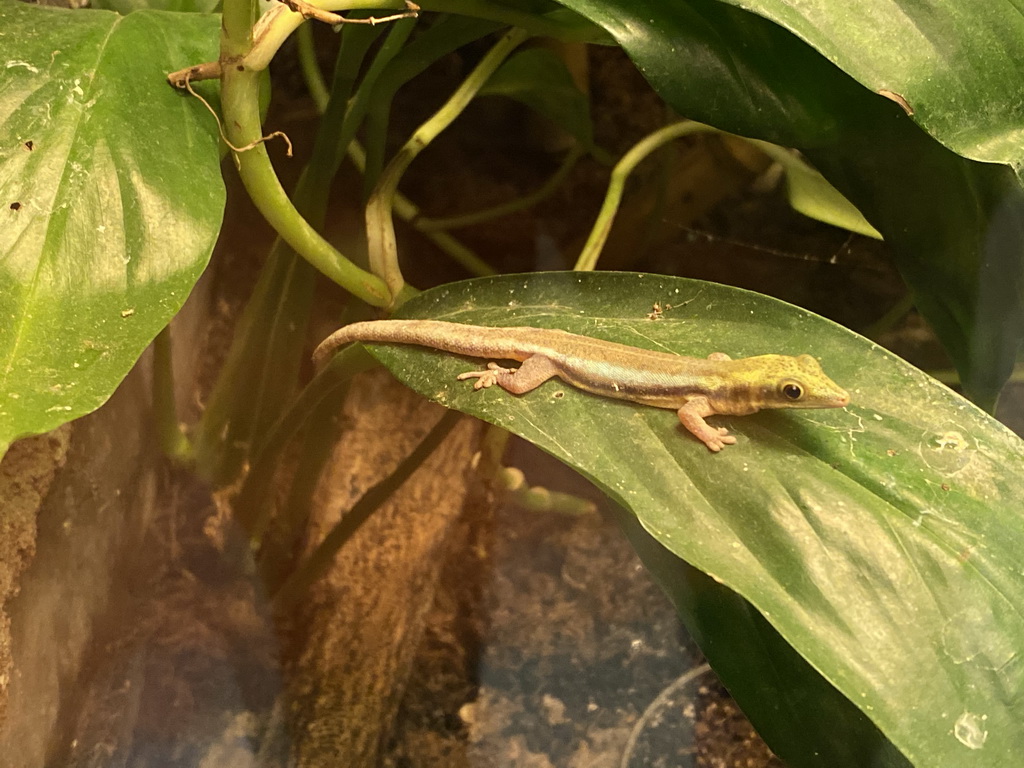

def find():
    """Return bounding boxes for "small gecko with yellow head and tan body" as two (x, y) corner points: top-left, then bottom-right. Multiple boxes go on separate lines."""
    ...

(313, 319), (850, 453)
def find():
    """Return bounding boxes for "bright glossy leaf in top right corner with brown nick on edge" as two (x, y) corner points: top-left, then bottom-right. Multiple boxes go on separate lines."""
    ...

(724, 0), (1024, 174)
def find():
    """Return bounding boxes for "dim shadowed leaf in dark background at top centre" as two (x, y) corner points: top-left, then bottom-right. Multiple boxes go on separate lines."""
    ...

(478, 48), (594, 151)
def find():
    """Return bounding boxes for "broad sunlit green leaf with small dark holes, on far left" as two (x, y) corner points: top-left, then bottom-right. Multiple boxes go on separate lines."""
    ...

(0, 0), (224, 454)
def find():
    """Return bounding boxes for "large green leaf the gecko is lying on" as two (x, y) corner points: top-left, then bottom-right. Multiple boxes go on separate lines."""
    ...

(352, 273), (1024, 768)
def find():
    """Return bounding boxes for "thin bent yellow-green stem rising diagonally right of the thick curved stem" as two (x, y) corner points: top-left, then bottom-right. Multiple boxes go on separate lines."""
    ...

(367, 29), (529, 296)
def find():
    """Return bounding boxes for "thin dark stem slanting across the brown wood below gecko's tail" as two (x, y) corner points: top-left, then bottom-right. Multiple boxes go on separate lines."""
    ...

(271, 411), (462, 612)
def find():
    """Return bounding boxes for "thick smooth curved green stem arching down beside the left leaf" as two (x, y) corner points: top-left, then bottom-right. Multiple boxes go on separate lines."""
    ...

(221, 57), (391, 306)
